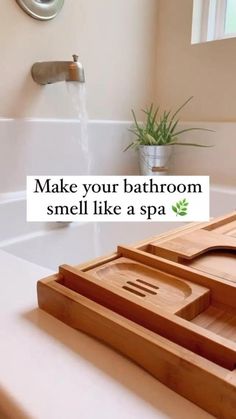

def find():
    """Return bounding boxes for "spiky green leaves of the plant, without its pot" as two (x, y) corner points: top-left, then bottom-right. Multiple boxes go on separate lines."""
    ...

(124, 96), (213, 151)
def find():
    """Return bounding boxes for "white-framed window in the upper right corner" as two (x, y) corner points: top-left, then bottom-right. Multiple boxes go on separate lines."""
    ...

(192, 0), (236, 44)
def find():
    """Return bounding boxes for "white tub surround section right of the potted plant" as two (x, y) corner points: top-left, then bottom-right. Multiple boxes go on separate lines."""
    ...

(172, 122), (236, 187)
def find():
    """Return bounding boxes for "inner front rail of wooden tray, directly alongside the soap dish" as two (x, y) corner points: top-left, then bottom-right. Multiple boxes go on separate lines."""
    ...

(59, 265), (236, 370)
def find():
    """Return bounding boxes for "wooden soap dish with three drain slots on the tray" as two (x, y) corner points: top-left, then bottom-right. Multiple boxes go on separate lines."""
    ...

(89, 257), (210, 320)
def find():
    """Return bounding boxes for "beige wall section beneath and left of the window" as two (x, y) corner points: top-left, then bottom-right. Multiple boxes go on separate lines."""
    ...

(156, 0), (236, 122)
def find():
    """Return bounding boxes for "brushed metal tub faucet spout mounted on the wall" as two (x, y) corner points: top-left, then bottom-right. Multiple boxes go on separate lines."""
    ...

(31, 54), (85, 84)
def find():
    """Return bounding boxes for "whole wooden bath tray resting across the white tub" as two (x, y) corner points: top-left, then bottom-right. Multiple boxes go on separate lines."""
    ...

(38, 213), (236, 419)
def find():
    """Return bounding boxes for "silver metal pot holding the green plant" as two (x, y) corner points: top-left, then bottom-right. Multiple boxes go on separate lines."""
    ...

(139, 145), (173, 176)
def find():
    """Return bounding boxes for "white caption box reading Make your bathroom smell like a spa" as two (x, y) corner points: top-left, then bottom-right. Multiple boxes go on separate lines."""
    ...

(27, 176), (209, 222)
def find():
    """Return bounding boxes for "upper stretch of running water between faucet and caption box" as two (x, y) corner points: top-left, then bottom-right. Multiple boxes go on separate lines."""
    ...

(66, 82), (92, 176)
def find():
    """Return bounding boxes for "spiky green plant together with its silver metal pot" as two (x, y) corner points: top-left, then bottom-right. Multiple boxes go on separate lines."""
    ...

(124, 97), (212, 176)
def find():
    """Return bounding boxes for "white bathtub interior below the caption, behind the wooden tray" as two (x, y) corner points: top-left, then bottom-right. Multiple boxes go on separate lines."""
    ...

(0, 222), (183, 270)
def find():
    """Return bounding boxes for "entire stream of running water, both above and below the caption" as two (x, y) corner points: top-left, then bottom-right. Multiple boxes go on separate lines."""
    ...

(66, 82), (101, 257)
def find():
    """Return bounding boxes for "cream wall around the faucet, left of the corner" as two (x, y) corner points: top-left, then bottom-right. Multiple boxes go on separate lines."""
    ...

(0, 0), (158, 120)
